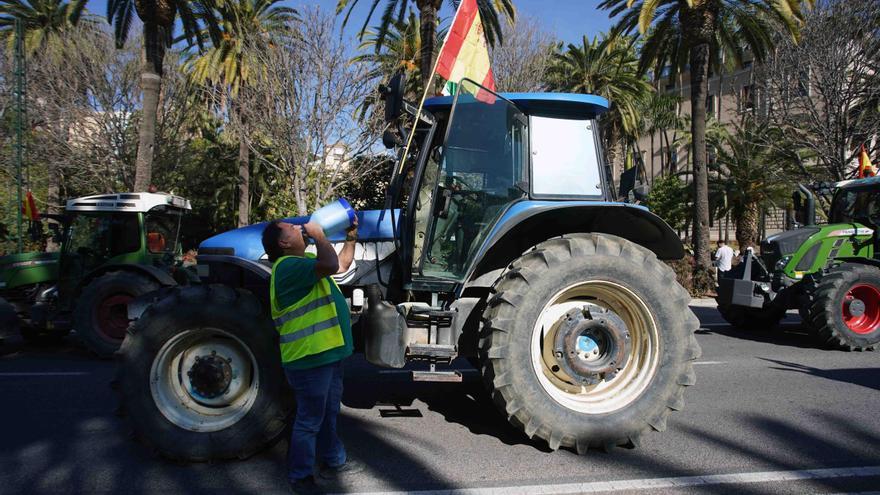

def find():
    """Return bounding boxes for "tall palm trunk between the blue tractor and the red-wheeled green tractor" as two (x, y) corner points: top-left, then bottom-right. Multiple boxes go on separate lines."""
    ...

(690, 43), (712, 271)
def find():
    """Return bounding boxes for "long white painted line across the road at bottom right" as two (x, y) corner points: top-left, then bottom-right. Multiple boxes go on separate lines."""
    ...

(336, 466), (880, 495)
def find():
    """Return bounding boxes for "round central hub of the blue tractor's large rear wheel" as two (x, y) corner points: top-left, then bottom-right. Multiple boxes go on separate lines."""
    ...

(553, 307), (630, 386)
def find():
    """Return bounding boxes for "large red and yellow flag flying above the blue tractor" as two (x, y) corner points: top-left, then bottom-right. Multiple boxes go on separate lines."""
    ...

(436, 0), (495, 95)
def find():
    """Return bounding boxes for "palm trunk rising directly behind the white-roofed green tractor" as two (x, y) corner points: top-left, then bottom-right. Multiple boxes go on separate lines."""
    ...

(134, 23), (165, 191)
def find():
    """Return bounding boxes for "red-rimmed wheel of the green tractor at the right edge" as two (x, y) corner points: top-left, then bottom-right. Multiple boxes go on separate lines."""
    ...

(805, 263), (880, 351)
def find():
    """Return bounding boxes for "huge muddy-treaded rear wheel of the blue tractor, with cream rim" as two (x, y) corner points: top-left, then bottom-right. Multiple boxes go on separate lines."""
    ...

(480, 234), (700, 454)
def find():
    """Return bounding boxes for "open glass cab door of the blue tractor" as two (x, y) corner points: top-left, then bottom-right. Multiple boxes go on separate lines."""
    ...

(415, 80), (528, 280)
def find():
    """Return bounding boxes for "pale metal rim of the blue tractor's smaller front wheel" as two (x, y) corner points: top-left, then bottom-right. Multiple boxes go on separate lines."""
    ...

(150, 328), (260, 432)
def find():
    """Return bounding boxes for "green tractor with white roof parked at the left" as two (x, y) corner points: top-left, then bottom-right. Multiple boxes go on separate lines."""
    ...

(0, 193), (191, 357)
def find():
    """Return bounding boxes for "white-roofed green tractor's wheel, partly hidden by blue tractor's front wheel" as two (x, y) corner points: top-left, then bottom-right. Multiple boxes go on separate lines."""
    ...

(73, 271), (159, 358)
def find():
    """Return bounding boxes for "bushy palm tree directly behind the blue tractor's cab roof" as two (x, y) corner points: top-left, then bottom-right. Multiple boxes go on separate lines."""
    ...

(547, 35), (652, 183)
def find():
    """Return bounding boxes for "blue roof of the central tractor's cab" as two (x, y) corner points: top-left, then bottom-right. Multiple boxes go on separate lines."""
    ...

(425, 93), (609, 119)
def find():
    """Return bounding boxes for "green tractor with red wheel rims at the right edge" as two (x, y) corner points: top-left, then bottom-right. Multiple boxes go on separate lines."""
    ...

(717, 177), (880, 350)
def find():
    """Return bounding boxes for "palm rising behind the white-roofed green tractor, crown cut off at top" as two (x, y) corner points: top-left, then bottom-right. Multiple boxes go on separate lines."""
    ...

(107, 0), (217, 191)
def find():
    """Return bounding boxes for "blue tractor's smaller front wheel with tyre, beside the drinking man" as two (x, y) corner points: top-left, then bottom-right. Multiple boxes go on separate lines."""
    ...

(117, 285), (293, 462)
